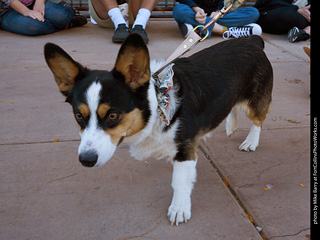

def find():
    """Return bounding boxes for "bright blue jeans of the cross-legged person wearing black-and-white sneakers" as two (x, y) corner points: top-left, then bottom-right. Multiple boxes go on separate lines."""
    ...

(173, 4), (259, 37)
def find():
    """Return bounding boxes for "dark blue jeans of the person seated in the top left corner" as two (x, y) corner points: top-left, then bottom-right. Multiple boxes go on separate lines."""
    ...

(1, 1), (75, 36)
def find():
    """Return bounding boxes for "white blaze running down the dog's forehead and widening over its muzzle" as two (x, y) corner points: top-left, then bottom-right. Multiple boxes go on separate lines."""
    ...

(78, 82), (117, 167)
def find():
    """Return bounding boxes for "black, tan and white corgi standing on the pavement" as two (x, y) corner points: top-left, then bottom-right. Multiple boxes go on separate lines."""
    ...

(44, 34), (273, 225)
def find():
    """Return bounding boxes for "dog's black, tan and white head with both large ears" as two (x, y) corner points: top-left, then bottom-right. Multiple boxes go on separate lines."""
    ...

(44, 34), (150, 167)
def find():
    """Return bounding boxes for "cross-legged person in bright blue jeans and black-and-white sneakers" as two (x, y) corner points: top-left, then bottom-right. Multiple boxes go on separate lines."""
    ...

(173, 0), (262, 38)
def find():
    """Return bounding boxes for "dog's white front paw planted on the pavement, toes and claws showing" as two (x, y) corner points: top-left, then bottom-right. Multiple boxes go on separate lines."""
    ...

(168, 198), (191, 226)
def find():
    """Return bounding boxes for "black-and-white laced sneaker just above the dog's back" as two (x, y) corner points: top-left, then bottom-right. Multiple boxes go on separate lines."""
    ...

(222, 23), (262, 39)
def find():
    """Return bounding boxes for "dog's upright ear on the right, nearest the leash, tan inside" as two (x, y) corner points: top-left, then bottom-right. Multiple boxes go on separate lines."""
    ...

(115, 34), (150, 90)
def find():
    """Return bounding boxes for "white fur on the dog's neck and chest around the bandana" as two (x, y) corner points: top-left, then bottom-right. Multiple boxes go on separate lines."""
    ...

(125, 60), (179, 160)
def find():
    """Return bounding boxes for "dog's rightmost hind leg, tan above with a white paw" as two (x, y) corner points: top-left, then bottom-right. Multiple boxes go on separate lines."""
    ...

(239, 100), (269, 152)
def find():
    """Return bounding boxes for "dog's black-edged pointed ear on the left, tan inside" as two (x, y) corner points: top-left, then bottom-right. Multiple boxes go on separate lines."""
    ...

(44, 43), (86, 98)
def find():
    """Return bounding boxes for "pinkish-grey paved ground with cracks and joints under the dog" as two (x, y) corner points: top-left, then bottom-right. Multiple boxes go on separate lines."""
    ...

(0, 21), (310, 240)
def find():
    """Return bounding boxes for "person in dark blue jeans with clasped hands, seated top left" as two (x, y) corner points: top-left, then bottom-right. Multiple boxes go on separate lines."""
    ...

(0, 0), (87, 36)
